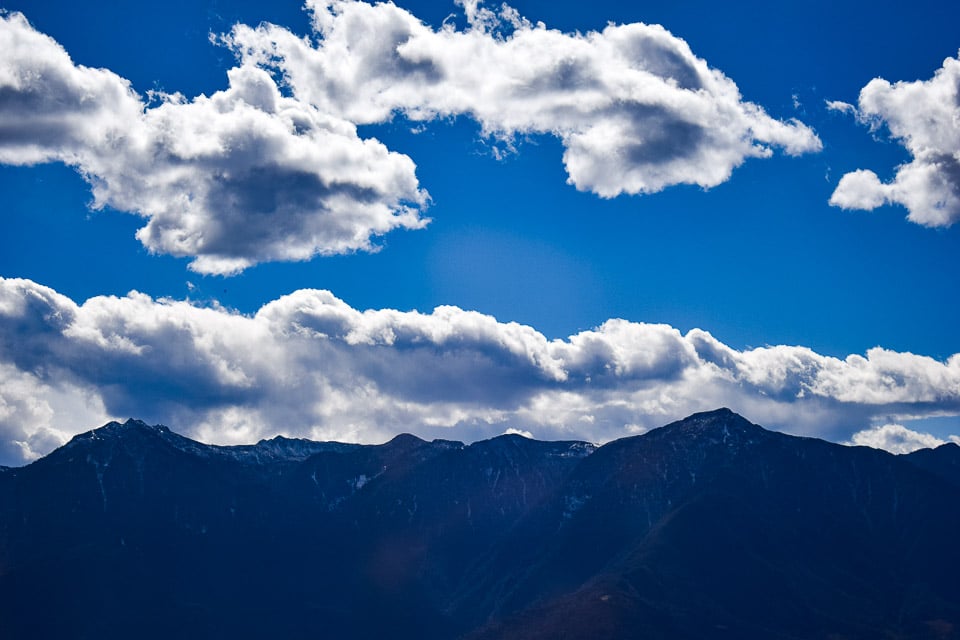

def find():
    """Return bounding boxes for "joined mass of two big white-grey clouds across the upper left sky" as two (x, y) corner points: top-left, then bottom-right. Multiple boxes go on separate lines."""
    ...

(0, 1), (820, 274)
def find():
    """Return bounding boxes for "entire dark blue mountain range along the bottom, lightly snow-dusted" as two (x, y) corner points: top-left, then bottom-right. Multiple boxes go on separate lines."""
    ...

(0, 409), (960, 640)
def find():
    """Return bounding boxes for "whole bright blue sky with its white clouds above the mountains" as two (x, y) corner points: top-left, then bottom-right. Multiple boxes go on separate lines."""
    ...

(0, 0), (960, 464)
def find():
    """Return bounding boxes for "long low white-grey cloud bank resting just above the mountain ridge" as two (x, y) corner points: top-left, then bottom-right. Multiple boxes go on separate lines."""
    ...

(0, 279), (960, 463)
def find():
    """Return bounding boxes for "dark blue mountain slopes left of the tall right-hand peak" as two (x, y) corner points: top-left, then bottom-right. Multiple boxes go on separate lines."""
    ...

(0, 421), (592, 638)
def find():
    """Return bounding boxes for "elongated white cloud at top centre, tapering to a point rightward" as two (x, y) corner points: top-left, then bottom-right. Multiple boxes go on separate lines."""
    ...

(227, 0), (821, 197)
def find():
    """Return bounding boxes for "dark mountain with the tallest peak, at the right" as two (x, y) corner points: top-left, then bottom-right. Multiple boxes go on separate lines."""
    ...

(462, 411), (960, 638)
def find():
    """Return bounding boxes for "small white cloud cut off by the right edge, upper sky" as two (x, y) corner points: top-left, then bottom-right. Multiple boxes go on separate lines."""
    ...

(828, 53), (960, 227)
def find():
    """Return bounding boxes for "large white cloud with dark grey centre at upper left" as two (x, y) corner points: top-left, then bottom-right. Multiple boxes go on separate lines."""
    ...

(0, 13), (428, 273)
